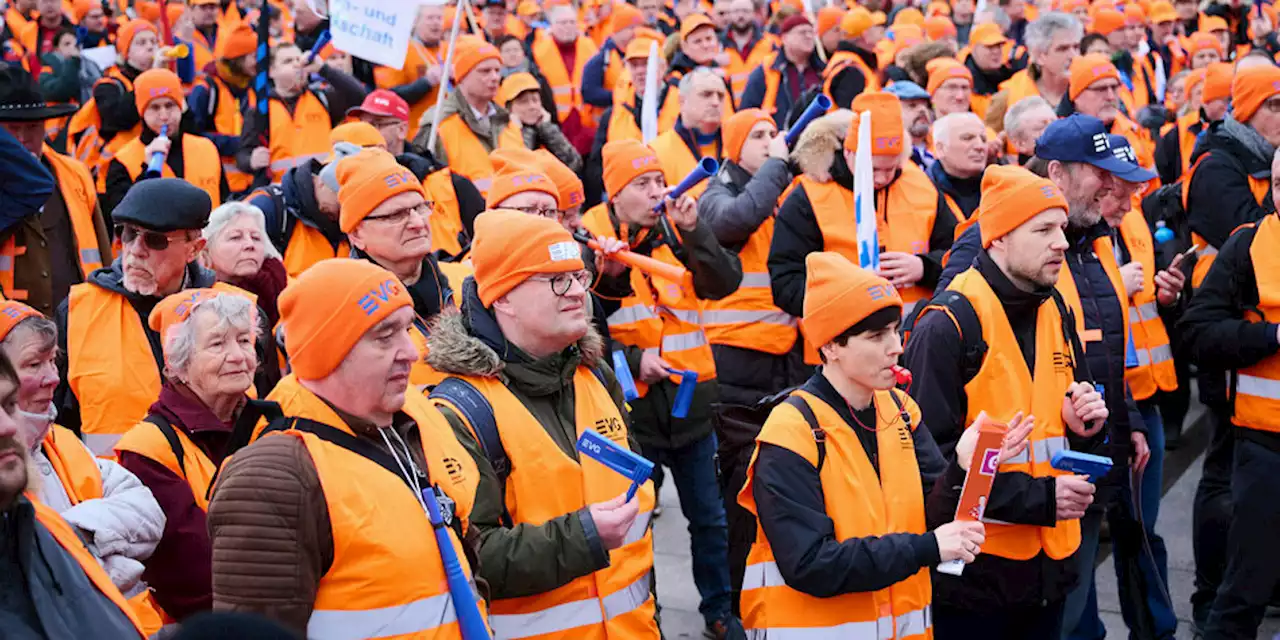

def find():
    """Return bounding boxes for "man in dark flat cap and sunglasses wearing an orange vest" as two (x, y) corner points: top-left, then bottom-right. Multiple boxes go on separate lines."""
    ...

(54, 178), (279, 456)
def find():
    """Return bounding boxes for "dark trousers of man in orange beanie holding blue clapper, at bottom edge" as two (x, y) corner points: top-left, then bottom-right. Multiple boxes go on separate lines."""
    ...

(933, 600), (1062, 640)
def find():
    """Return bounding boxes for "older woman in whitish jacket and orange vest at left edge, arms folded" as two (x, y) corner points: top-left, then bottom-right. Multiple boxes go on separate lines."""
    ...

(0, 301), (165, 613)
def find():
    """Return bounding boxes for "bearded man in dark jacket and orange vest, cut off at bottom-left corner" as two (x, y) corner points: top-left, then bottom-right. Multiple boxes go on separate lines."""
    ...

(0, 355), (143, 640)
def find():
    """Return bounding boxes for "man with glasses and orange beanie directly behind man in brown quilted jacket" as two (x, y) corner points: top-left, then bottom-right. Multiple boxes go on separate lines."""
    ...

(332, 148), (471, 387)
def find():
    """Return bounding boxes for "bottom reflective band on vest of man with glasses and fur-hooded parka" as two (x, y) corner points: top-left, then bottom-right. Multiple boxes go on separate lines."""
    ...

(489, 573), (650, 639)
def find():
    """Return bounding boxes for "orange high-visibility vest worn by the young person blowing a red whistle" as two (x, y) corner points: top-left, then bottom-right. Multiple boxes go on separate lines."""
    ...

(737, 390), (933, 640)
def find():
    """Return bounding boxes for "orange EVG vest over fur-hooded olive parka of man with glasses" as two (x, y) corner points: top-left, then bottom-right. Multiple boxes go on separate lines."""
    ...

(434, 365), (659, 640)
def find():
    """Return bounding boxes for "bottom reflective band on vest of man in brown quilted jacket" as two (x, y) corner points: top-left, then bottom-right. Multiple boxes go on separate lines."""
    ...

(307, 591), (458, 640)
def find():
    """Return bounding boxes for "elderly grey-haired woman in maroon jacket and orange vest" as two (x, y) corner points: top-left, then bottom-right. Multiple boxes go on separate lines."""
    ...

(115, 285), (267, 621)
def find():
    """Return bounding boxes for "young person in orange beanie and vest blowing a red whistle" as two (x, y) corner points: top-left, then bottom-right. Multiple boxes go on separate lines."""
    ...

(739, 252), (1032, 639)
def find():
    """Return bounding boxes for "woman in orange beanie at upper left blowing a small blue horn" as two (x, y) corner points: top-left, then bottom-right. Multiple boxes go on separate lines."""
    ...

(102, 69), (230, 216)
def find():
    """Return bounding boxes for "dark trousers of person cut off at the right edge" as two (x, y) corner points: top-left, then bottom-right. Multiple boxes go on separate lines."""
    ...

(1204, 438), (1280, 640)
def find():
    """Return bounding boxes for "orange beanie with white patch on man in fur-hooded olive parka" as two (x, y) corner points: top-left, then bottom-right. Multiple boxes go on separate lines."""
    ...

(471, 209), (586, 303)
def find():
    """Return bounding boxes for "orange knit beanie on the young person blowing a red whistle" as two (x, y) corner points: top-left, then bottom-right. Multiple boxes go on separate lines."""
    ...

(800, 251), (902, 347)
